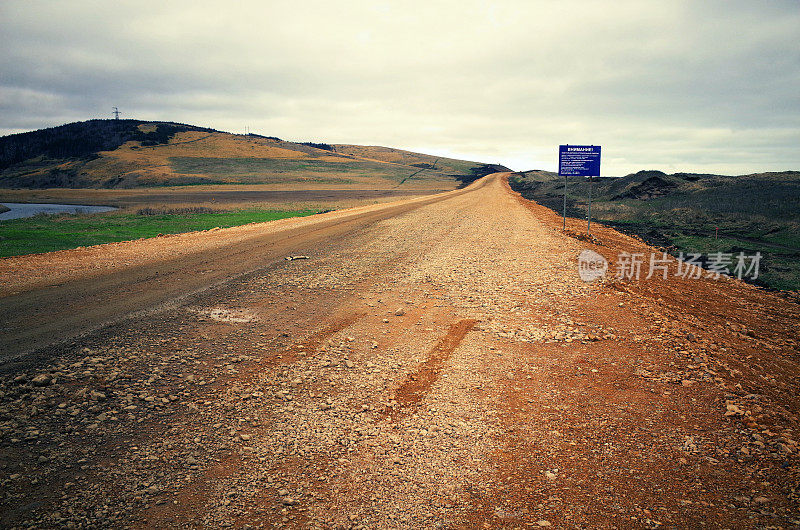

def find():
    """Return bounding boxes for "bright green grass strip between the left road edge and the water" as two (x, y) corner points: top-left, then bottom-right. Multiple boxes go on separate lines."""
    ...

(0, 208), (319, 257)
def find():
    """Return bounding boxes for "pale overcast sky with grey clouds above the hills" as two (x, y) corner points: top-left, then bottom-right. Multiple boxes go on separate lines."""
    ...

(0, 0), (800, 175)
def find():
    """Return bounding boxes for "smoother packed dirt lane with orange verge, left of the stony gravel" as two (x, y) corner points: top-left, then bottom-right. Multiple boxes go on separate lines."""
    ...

(0, 184), (482, 361)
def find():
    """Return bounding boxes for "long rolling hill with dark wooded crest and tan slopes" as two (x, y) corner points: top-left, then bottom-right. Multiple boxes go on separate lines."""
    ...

(0, 120), (500, 190)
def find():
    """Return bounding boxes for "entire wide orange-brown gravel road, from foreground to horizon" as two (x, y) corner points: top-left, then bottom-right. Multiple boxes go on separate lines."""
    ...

(0, 174), (800, 528)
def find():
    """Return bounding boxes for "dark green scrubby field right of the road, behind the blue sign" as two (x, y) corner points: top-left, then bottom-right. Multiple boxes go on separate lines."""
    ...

(511, 171), (800, 291)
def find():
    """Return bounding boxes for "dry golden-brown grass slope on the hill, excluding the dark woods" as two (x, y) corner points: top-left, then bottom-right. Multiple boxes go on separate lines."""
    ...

(51, 131), (471, 190)
